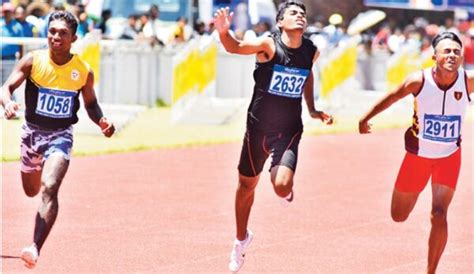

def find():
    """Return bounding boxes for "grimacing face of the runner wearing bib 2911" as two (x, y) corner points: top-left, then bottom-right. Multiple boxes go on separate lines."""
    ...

(433, 39), (463, 72)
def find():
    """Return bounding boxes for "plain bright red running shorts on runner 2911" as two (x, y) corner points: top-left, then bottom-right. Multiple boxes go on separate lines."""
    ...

(395, 149), (461, 193)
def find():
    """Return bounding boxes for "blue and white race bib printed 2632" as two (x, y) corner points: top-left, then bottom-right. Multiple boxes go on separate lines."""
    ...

(268, 65), (310, 98)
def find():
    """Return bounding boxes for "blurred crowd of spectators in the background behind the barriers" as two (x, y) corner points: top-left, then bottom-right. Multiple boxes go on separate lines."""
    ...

(0, 0), (474, 69)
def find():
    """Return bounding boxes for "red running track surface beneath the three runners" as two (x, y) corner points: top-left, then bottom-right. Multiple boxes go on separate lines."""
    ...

(2, 127), (474, 273)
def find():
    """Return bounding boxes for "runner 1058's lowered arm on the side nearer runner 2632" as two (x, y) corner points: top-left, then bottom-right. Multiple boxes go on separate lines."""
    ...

(82, 71), (115, 137)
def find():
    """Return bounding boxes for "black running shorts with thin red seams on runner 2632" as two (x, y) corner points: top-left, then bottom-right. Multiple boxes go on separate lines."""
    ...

(238, 130), (302, 177)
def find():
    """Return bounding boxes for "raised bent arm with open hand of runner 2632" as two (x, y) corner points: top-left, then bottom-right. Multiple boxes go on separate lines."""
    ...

(214, 7), (275, 62)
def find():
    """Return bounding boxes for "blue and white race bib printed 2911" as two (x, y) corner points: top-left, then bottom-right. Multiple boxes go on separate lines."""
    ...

(423, 114), (461, 143)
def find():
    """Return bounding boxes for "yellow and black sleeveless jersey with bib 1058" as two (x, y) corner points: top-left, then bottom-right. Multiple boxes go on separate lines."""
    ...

(25, 50), (90, 129)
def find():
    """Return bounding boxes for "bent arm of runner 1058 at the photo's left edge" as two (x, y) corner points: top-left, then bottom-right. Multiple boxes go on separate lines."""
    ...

(0, 54), (33, 119)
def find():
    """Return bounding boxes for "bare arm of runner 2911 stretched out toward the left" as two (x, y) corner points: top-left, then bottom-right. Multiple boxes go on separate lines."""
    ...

(359, 71), (423, 134)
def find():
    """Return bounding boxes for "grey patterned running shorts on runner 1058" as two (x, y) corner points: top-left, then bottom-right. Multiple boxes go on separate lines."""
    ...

(21, 123), (73, 173)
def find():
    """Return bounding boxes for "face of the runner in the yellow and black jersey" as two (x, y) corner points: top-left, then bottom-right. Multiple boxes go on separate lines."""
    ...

(48, 20), (77, 52)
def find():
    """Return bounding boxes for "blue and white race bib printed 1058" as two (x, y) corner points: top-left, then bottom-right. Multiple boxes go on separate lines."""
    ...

(36, 88), (77, 118)
